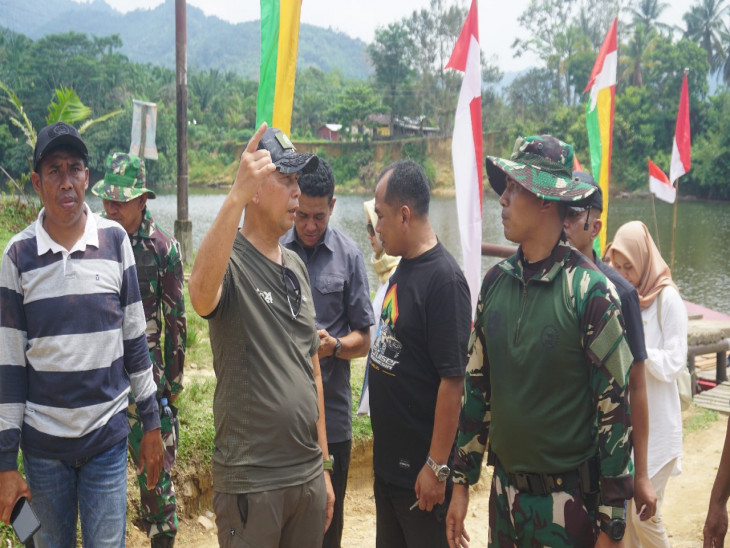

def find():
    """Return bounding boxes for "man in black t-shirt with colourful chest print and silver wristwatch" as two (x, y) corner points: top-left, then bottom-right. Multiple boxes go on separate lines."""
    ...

(368, 160), (471, 548)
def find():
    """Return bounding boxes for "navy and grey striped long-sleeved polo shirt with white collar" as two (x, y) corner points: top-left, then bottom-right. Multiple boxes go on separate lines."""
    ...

(0, 204), (160, 470)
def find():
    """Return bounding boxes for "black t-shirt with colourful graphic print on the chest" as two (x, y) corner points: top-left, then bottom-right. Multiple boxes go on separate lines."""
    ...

(368, 243), (471, 488)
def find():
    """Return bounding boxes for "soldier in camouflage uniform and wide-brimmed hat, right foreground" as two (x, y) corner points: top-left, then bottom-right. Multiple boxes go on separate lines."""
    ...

(447, 135), (633, 547)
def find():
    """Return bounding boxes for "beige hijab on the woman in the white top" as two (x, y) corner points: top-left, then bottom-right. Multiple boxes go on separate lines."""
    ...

(609, 221), (679, 309)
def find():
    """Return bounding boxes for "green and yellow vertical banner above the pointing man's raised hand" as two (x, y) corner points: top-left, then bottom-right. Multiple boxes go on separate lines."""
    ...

(256, 0), (302, 135)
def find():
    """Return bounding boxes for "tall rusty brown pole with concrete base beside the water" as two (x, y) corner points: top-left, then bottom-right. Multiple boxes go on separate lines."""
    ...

(175, 0), (193, 264)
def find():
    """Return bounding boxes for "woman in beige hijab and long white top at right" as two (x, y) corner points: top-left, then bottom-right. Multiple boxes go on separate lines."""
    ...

(609, 221), (687, 548)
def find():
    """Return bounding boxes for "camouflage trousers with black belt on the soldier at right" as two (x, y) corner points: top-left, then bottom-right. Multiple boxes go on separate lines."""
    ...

(489, 463), (599, 548)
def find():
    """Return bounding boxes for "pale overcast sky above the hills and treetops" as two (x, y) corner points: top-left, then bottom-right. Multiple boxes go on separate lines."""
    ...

(75, 0), (694, 71)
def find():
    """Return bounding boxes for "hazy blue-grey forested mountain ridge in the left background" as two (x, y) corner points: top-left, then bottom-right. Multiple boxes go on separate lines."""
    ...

(0, 0), (372, 80)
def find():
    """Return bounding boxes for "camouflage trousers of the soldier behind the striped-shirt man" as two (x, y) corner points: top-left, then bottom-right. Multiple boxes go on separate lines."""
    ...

(127, 403), (177, 538)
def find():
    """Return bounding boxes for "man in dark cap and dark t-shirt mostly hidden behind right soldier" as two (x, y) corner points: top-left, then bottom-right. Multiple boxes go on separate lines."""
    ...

(563, 171), (657, 522)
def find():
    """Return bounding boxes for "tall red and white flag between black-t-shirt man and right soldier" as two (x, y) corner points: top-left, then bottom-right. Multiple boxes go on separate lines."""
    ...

(446, 0), (483, 314)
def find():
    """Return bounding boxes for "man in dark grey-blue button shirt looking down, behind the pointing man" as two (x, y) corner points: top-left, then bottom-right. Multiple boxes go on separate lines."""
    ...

(281, 159), (375, 548)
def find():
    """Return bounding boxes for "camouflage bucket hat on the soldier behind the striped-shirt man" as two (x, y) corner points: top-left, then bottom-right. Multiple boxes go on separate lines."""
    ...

(91, 152), (155, 202)
